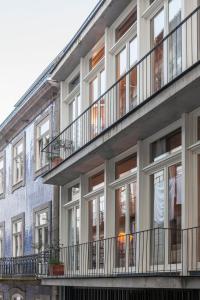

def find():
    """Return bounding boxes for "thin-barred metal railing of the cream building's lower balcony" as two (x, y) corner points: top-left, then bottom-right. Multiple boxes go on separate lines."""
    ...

(38, 227), (200, 278)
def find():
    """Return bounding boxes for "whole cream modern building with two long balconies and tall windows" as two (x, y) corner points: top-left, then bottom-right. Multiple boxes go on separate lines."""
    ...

(42, 0), (200, 299)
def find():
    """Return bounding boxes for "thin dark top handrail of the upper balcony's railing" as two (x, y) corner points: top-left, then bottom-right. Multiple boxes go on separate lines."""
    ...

(42, 5), (200, 153)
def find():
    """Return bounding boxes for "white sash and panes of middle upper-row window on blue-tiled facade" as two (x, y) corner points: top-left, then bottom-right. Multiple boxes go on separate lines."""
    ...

(13, 138), (25, 185)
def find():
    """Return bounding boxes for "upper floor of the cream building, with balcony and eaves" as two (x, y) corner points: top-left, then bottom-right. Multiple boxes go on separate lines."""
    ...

(44, 0), (200, 185)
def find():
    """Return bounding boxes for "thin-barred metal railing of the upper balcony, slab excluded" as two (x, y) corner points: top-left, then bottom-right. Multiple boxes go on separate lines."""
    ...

(43, 7), (200, 168)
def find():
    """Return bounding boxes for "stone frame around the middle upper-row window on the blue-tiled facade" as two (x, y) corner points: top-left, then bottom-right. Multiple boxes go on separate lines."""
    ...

(12, 132), (26, 192)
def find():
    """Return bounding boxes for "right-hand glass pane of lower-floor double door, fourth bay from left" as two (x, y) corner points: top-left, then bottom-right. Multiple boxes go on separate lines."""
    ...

(168, 164), (182, 263)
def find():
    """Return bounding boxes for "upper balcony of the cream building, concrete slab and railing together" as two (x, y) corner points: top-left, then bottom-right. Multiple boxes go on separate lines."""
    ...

(43, 7), (200, 185)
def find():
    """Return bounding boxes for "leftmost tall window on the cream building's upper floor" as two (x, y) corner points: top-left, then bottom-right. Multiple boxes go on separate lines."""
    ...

(69, 93), (81, 149)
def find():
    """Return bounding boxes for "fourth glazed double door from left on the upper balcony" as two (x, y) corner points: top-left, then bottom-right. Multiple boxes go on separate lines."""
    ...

(150, 0), (182, 93)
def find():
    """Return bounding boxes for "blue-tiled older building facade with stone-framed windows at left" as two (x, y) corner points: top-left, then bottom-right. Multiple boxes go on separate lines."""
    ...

(0, 61), (58, 300)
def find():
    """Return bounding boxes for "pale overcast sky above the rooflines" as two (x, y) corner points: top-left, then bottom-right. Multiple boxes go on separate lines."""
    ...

(0, 0), (98, 123)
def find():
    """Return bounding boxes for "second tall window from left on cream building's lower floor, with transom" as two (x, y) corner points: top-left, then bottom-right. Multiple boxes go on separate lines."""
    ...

(88, 171), (104, 269)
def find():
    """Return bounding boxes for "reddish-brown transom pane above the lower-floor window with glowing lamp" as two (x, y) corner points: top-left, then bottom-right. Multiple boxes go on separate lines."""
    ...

(115, 155), (137, 179)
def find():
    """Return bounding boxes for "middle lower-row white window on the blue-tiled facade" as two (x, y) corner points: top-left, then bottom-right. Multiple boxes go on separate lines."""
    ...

(12, 219), (23, 257)
